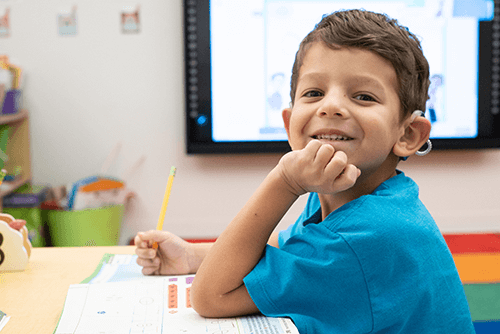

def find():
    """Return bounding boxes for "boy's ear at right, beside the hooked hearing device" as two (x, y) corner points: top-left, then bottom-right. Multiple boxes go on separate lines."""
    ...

(392, 116), (431, 157)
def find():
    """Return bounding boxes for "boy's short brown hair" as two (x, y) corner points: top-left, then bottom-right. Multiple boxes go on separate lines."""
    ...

(290, 10), (430, 117)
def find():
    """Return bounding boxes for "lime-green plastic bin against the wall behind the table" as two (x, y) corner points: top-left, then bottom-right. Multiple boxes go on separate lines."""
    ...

(43, 205), (125, 247)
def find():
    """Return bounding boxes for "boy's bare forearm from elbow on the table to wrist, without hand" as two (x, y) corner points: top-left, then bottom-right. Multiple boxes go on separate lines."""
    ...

(191, 168), (298, 317)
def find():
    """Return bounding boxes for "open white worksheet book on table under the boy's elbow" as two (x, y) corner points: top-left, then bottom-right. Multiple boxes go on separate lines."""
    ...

(54, 254), (298, 334)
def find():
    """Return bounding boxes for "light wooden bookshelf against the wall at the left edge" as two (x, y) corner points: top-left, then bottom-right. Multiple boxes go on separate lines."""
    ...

(0, 109), (31, 212)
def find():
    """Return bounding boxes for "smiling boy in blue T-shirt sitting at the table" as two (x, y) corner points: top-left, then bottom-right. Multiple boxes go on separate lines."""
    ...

(135, 10), (474, 334)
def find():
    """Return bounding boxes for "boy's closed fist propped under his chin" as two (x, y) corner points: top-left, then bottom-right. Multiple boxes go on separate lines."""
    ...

(278, 140), (361, 196)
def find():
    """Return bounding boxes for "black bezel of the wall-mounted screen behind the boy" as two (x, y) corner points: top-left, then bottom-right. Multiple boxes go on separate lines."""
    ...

(184, 0), (500, 154)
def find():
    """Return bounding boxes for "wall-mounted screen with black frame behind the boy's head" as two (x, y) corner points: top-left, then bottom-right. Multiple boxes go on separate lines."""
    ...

(184, 0), (500, 153)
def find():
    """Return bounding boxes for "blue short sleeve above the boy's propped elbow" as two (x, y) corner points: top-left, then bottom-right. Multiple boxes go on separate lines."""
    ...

(244, 224), (373, 333)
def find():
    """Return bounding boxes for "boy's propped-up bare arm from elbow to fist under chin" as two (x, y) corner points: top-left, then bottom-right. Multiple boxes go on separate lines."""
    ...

(191, 141), (359, 317)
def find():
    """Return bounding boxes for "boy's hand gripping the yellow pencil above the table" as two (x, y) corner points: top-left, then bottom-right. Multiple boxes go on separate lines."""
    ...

(134, 230), (193, 275)
